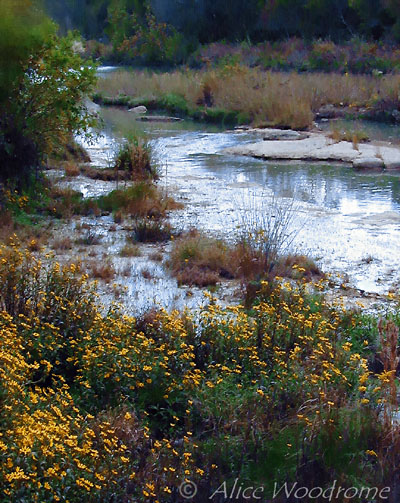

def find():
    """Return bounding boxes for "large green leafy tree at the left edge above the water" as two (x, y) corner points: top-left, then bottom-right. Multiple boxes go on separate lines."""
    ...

(0, 0), (96, 185)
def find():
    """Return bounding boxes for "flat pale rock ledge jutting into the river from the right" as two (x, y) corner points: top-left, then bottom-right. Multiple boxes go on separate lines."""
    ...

(224, 130), (400, 172)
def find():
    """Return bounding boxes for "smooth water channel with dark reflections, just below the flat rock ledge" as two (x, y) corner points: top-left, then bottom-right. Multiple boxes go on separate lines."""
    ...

(97, 109), (400, 214)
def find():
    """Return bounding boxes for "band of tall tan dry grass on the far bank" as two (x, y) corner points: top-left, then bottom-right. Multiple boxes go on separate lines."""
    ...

(98, 66), (400, 129)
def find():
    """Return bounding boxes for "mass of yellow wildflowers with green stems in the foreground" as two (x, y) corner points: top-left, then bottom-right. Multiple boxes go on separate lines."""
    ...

(0, 240), (396, 503)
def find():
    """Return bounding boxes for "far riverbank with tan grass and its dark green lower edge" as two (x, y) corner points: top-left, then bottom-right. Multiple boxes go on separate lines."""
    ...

(94, 65), (400, 130)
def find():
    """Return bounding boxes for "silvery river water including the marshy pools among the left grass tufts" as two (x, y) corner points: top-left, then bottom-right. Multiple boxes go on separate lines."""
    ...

(38, 112), (399, 311)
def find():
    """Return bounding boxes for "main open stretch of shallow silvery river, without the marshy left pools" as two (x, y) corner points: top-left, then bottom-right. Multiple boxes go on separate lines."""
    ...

(76, 109), (400, 293)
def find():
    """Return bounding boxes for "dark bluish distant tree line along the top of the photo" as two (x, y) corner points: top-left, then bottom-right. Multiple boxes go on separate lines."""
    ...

(46, 0), (400, 43)
